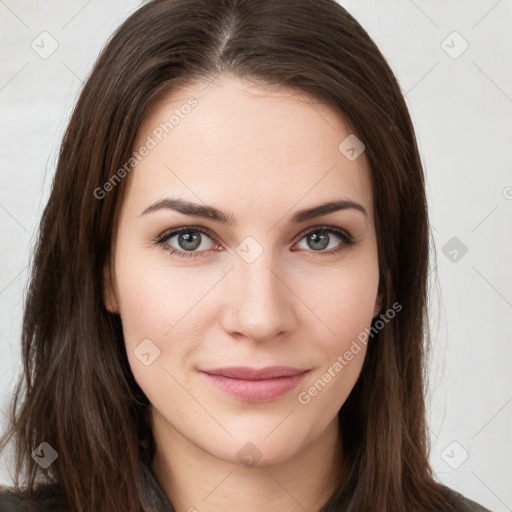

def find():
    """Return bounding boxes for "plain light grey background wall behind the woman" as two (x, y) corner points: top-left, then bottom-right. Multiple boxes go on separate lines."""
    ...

(0, 0), (512, 512)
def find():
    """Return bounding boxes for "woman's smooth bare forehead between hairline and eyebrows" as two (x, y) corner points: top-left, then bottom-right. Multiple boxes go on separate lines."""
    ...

(127, 75), (373, 220)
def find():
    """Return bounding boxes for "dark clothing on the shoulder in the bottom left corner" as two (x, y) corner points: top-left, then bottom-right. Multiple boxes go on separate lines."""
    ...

(0, 484), (66, 512)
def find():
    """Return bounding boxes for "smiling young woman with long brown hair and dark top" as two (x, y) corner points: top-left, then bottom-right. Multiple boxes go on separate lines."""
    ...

(0, 0), (492, 512)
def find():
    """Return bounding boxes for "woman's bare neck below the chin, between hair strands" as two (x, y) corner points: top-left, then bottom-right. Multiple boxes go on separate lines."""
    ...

(151, 412), (345, 512)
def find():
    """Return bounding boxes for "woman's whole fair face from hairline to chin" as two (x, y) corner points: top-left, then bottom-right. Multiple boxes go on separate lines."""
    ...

(105, 75), (379, 465)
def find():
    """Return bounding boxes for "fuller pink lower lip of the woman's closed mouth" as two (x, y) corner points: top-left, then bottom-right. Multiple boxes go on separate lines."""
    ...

(202, 370), (309, 402)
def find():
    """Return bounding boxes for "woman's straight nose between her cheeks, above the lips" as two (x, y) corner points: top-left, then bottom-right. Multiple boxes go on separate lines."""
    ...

(222, 251), (298, 343)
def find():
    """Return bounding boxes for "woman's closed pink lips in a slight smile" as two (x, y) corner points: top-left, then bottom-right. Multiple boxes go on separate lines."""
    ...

(200, 366), (310, 402)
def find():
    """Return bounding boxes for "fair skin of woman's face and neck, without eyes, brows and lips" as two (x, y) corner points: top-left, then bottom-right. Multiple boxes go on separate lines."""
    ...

(104, 75), (379, 512)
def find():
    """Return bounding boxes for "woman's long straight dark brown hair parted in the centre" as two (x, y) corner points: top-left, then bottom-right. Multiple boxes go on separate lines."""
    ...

(0, 0), (470, 512)
